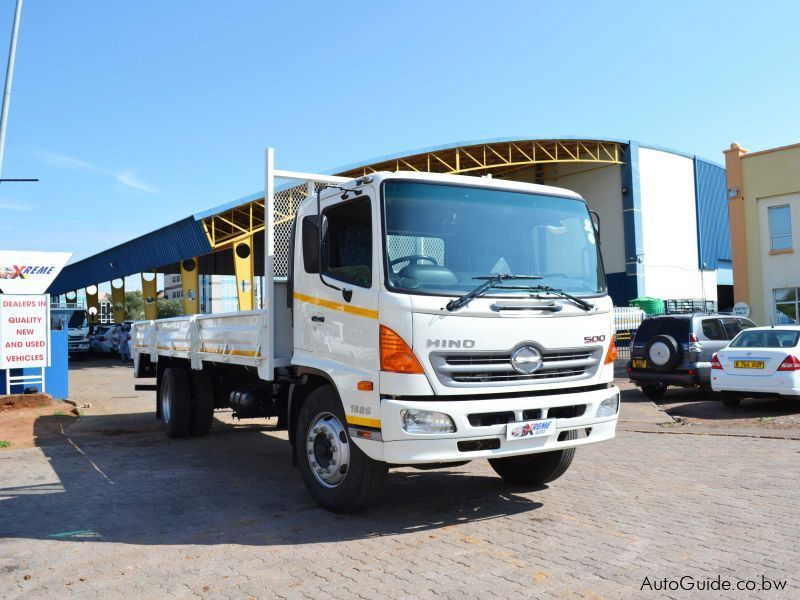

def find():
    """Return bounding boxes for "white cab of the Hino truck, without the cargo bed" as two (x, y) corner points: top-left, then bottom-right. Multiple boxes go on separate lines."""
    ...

(292, 173), (617, 464)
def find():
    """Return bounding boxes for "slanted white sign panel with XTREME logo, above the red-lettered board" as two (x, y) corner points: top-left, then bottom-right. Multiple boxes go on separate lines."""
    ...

(0, 250), (72, 294)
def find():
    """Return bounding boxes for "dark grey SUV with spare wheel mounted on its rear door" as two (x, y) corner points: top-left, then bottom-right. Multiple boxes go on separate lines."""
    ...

(628, 313), (755, 400)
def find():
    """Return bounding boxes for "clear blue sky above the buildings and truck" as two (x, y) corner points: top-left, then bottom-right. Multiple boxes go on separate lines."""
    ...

(0, 0), (800, 268)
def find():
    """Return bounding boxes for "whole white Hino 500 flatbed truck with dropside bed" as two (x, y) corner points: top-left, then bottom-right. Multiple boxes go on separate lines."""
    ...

(132, 149), (619, 512)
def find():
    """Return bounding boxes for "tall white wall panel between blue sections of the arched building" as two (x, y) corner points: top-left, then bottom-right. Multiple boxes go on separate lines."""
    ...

(639, 147), (717, 300)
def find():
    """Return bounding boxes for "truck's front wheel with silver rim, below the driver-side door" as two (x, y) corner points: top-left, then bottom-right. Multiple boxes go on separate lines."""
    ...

(294, 385), (388, 513)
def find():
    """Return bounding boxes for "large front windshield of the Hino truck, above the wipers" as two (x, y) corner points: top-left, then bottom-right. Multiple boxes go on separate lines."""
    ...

(384, 181), (605, 296)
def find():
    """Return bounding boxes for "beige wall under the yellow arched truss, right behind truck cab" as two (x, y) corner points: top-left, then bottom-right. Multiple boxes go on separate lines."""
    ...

(545, 164), (625, 273)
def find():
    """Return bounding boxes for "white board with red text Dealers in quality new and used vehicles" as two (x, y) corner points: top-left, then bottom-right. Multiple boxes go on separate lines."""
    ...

(0, 294), (50, 369)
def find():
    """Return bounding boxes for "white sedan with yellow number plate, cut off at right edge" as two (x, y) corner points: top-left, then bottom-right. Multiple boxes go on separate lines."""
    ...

(711, 325), (800, 407)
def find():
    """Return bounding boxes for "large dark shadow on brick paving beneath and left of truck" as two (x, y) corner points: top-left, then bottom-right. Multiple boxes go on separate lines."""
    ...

(0, 413), (542, 545)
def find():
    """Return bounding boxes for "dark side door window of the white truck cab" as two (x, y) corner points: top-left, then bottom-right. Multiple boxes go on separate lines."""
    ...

(322, 198), (372, 287)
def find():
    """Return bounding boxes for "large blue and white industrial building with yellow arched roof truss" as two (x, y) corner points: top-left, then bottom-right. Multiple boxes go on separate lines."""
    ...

(43, 138), (733, 317)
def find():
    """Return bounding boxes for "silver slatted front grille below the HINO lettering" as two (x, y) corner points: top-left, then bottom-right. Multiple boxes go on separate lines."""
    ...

(430, 348), (602, 387)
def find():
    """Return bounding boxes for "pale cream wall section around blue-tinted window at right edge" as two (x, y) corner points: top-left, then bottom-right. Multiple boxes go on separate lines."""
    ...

(758, 193), (800, 324)
